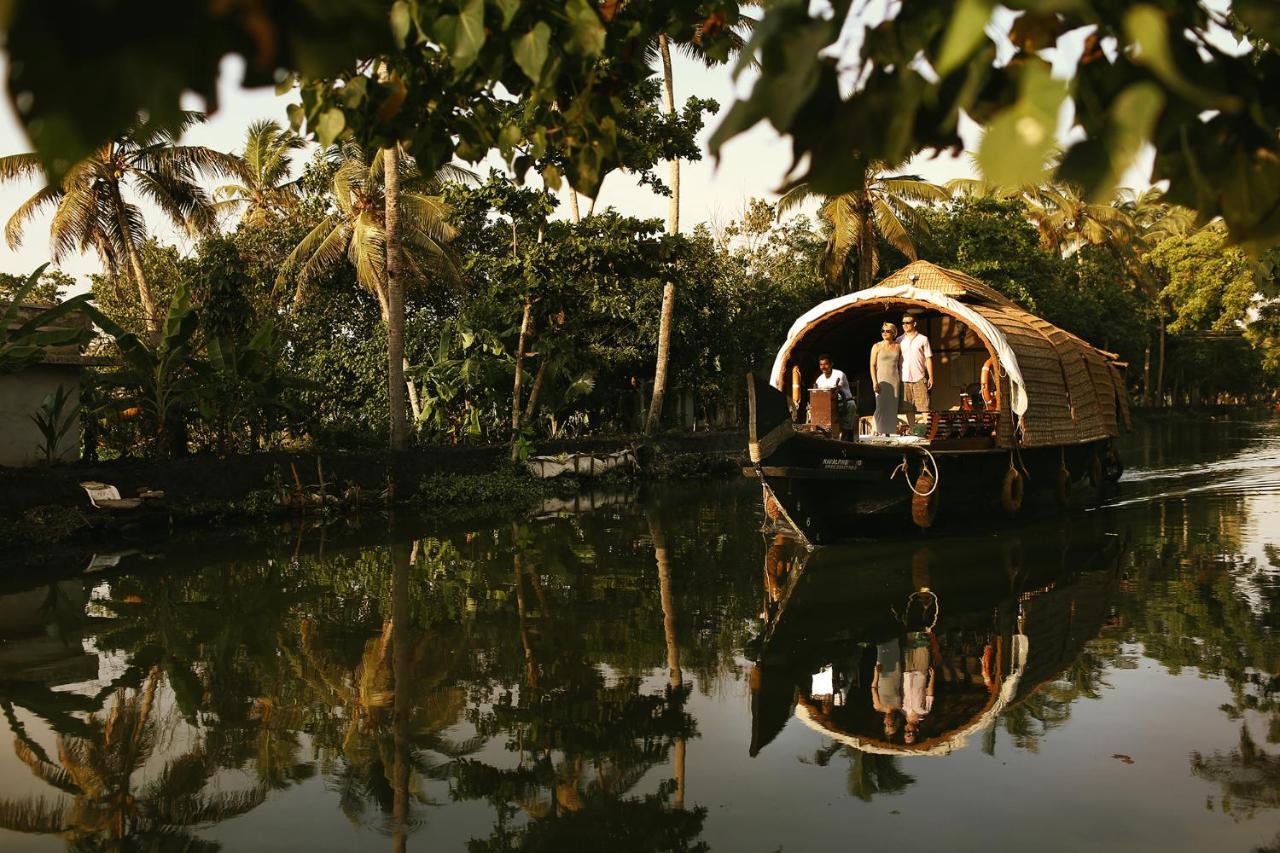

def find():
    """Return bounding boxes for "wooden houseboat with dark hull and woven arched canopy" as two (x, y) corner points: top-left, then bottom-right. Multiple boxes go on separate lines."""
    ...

(748, 261), (1132, 544)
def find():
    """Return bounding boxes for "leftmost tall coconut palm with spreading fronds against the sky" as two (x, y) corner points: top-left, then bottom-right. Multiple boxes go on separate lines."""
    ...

(0, 113), (247, 336)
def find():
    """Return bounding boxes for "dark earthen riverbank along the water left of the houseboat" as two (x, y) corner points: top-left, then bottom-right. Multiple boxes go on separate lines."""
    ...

(0, 432), (746, 562)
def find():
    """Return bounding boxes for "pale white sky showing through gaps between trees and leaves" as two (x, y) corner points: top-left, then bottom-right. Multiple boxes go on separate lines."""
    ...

(0, 7), (1172, 295)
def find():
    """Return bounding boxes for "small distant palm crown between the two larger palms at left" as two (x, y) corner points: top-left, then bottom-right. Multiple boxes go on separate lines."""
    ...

(214, 119), (306, 224)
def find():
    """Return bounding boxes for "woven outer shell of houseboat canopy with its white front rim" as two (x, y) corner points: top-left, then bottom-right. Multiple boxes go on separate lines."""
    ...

(772, 261), (1132, 447)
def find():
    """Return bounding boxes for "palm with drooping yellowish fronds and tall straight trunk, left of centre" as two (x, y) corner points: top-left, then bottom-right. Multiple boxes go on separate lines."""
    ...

(276, 142), (475, 450)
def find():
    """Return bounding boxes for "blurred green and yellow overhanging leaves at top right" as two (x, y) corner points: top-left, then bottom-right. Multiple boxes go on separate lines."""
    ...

(712, 0), (1280, 248)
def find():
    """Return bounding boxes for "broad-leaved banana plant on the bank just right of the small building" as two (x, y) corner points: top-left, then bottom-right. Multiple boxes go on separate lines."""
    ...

(83, 282), (200, 456)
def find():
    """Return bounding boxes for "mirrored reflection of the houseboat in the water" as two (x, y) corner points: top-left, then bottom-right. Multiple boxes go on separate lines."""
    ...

(750, 517), (1123, 757)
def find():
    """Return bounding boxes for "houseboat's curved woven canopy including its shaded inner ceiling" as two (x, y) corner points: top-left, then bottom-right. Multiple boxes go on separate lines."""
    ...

(769, 261), (1130, 447)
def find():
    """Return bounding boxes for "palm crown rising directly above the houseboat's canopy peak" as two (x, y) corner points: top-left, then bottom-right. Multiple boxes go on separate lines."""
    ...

(778, 163), (947, 289)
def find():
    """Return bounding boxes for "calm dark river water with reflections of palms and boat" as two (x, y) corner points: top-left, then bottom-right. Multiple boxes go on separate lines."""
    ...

(0, 414), (1280, 852)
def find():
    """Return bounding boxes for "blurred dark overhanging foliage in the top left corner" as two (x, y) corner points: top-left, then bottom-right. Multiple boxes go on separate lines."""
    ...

(5, 0), (392, 178)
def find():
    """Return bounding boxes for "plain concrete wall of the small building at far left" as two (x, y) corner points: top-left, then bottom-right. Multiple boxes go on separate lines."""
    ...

(0, 364), (81, 467)
